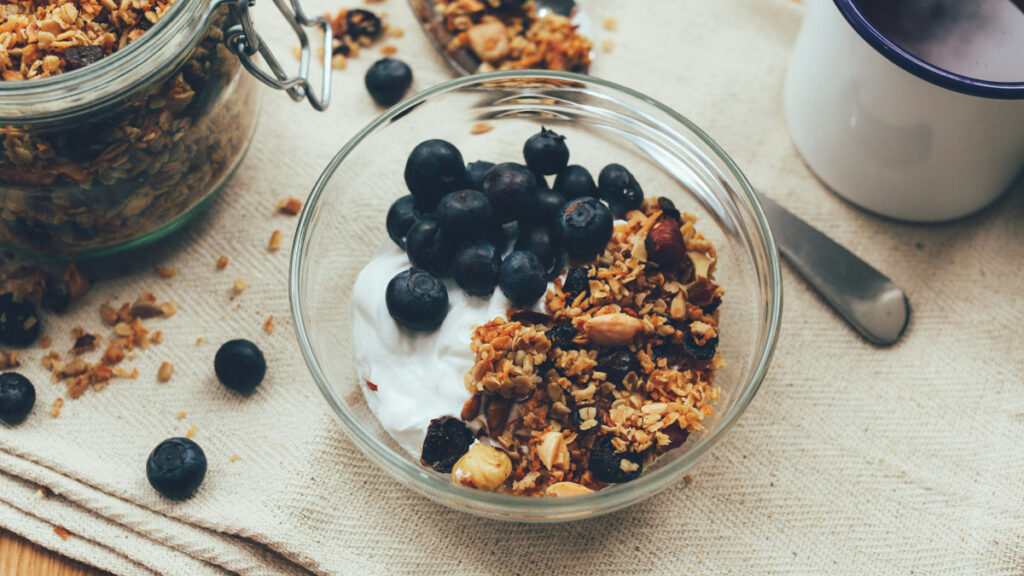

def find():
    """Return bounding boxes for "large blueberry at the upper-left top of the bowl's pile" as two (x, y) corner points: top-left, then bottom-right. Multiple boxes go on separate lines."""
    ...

(404, 139), (466, 211)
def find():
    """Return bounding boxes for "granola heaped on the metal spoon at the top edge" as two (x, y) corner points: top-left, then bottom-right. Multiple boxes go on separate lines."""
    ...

(434, 0), (593, 72)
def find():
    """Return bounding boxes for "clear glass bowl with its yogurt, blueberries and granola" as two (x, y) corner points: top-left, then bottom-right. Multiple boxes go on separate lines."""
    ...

(292, 72), (781, 521)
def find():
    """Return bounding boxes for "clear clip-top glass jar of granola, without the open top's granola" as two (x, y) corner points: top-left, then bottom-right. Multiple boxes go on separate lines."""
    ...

(0, 0), (327, 257)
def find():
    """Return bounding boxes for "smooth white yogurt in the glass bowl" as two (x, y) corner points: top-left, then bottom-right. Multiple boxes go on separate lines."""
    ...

(352, 243), (511, 457)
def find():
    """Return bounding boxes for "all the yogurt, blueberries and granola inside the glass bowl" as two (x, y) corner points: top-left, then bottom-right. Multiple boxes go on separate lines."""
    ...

(352, 128), (724, 497)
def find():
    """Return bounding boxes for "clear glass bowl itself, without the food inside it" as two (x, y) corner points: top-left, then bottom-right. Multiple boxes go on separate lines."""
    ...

(290, 71), (781, 522)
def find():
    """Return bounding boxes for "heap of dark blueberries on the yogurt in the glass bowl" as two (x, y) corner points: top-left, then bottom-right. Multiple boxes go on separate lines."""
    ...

(385, 128), (643, 331)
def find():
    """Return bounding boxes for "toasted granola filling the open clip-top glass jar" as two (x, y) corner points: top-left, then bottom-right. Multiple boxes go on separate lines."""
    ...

(0, 0), (257, 255)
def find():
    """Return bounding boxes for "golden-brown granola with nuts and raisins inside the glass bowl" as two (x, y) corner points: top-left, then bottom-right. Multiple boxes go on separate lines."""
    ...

(462, 199), (724, 496)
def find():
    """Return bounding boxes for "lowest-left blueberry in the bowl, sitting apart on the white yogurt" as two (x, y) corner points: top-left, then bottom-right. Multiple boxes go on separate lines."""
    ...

(384, 268), (449, 332)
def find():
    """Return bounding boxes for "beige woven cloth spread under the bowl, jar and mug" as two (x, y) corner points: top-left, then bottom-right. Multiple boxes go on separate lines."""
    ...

(0, 0), (1024, 576)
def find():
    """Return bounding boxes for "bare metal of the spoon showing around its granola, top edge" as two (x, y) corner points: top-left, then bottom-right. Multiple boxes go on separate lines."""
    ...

(409, 0), (594, 76)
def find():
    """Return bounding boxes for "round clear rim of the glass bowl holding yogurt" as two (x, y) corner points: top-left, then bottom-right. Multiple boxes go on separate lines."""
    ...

(289, 70), (782, 512)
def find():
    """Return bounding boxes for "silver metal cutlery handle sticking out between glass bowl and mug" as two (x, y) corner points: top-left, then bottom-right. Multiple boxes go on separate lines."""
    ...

(758, 192), (910, 345)
